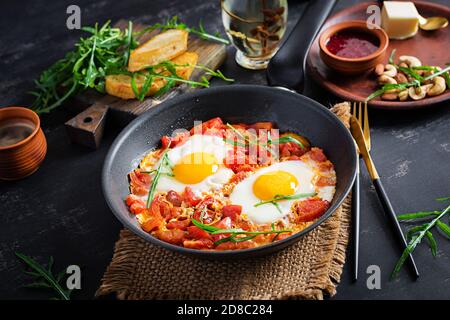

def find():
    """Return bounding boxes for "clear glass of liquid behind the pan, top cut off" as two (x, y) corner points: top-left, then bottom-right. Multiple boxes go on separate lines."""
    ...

(221, 0), (288, 69)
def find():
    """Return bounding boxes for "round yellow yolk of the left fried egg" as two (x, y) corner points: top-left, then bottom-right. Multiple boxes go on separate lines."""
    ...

(172, 152), (219, 184)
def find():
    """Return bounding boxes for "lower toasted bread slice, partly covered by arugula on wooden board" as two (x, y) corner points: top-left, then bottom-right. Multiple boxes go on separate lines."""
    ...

(105, 52), (198, 100)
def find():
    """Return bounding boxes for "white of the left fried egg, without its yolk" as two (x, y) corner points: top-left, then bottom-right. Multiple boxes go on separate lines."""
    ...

(154, 135), (234, 196)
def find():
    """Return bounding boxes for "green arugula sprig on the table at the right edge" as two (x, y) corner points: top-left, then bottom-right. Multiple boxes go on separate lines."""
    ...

(391, 197), (450, 279)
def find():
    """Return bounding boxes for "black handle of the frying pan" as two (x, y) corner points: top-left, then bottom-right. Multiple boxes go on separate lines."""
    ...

(267, 0), (336, 92)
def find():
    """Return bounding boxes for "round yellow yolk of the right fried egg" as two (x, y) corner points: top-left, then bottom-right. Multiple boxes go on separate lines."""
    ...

(253, 170), (298, 200)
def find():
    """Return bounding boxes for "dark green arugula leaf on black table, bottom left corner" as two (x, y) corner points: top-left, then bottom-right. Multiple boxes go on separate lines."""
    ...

(16, 252), (72, 300)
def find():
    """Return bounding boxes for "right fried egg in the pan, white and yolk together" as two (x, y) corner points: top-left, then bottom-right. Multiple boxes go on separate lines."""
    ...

(230, 160), (334, 225)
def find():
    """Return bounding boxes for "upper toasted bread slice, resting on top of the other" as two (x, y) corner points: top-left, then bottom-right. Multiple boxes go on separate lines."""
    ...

(128, 29), (189, 72)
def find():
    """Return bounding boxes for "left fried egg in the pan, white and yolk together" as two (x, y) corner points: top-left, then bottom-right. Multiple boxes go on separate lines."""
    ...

(154, 135), (233, 195)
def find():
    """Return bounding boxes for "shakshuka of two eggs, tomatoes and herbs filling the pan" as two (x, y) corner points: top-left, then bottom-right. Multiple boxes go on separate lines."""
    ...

(125, 118), (336, 250)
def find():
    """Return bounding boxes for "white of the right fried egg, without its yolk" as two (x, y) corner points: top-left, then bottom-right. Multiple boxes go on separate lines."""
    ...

(230, 160), (334, 225)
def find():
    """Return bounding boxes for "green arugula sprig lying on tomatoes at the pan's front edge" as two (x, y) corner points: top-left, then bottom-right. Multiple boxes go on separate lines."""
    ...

(192, 219), (292, 245)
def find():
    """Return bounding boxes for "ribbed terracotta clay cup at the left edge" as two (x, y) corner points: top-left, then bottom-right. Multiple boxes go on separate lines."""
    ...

(0, 107), (47, 180)
